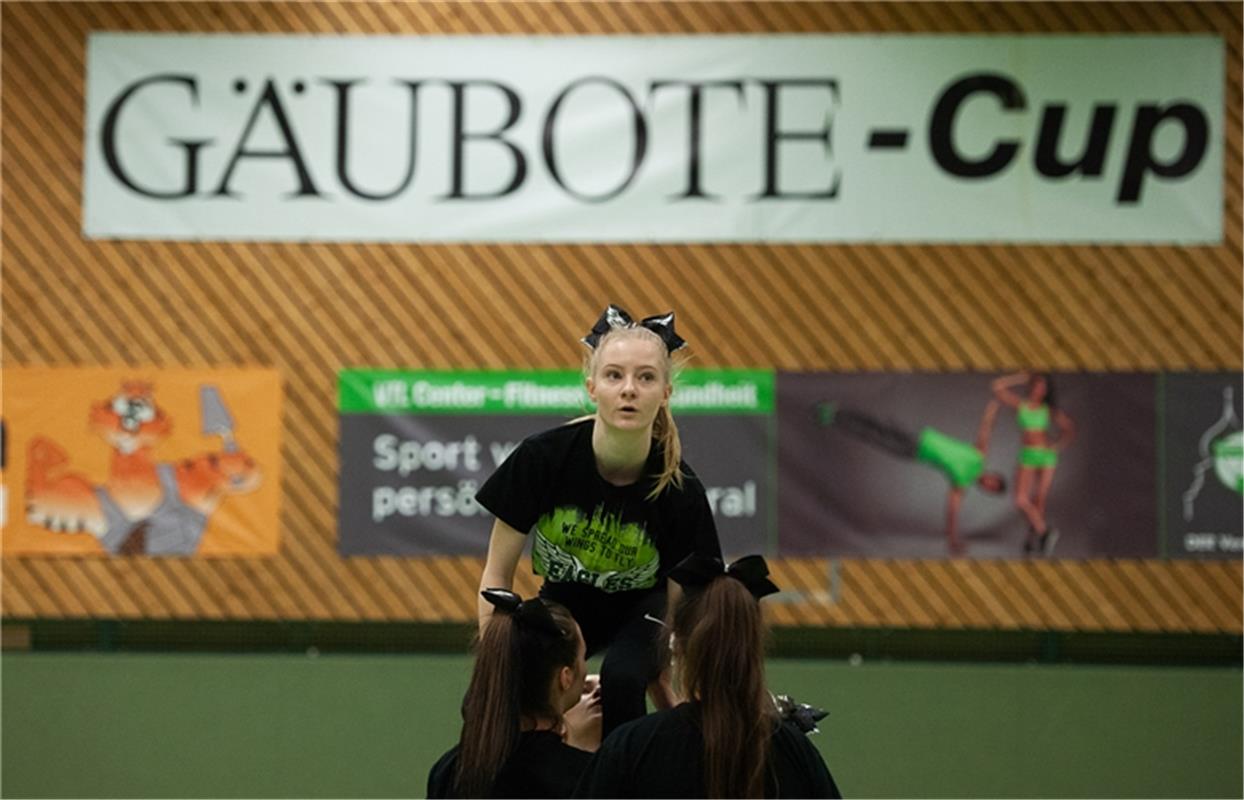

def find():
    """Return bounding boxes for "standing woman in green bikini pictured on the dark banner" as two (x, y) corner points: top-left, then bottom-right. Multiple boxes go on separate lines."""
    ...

(993, 372), (1076, 555)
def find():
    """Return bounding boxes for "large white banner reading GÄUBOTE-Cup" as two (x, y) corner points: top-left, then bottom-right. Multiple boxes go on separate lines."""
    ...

(82, 34), (1224, 243)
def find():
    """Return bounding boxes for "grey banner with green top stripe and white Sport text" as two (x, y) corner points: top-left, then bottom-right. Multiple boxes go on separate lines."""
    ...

(338, 370), (775, 555)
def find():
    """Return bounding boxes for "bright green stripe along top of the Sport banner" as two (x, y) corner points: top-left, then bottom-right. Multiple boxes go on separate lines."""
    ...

(337, 370), (774, 414)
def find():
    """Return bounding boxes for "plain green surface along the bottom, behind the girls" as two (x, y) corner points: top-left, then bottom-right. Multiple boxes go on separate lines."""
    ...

(0, 652), (1244, 798)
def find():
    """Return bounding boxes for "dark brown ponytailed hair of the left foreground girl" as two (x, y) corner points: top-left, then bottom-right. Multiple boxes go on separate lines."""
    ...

(454, 600), (578, 798)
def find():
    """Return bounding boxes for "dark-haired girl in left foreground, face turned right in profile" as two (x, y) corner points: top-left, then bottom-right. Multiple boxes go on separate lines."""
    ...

(428, 588), (601, 798)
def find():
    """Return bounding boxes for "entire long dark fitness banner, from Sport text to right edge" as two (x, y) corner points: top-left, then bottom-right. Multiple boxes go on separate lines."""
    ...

(340, 371), (1244, 559)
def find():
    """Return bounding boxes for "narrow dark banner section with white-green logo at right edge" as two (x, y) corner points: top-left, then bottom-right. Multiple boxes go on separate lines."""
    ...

(1159, 372), (1244, 559)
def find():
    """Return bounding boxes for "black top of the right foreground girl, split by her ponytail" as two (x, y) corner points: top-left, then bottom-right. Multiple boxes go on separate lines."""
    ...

(575, 703), (842, 798)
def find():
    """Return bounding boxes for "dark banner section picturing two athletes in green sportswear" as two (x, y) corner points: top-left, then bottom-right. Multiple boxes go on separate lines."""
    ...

(778, 373), (1159, 557)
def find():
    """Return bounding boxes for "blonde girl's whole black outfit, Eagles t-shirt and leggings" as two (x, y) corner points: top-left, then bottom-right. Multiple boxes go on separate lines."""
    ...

(475, 419), (722, 735)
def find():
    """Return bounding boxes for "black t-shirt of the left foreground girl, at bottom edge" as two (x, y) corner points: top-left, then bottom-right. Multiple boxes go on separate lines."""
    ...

(428, 730), (592, 798)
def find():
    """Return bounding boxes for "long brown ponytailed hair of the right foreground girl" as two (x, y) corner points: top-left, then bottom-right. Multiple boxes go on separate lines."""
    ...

(671, 576), (778, 798)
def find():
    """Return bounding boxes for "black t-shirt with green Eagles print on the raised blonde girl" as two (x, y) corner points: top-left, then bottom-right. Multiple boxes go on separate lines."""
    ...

(475, 419), (722, 608)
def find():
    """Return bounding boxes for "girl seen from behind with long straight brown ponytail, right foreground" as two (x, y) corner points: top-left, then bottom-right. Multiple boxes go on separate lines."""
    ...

(575, 556), (841, 798)
